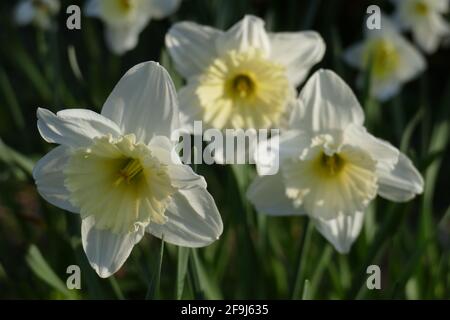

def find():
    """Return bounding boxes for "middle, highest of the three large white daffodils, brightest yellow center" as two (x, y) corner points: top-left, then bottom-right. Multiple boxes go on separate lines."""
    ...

(166, 15), (325, 130)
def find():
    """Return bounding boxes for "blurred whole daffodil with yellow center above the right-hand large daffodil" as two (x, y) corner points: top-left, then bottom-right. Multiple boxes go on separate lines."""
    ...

(344, 16), (426, 101)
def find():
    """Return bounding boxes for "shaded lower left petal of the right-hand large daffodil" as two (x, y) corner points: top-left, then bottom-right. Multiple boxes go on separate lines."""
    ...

(247, 173), (305, 216)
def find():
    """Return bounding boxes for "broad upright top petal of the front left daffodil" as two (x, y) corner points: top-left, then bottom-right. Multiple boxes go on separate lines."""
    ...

(102, 62), (178, 144)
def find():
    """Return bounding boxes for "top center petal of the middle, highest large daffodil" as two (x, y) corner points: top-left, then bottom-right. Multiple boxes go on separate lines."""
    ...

(216, 15), (270, 56)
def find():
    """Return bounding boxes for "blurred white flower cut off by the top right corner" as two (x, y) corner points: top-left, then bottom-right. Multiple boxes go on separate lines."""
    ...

(392, 0), (450, 53)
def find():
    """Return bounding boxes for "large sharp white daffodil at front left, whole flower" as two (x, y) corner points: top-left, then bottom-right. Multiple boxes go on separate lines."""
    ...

(33, 62), (222, 277)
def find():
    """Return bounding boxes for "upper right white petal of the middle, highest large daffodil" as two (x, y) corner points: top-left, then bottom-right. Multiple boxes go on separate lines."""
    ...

(269, 31), (325, 86)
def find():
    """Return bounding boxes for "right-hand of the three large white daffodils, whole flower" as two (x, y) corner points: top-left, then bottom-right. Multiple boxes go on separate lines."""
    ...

(247, 70), (423, 253)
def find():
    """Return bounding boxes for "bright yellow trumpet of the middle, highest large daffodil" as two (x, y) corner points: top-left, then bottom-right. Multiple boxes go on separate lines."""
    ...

(196, 48), (293, 129)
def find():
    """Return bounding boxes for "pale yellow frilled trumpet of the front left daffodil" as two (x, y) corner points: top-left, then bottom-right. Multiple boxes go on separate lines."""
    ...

(64, 135), (175, 233)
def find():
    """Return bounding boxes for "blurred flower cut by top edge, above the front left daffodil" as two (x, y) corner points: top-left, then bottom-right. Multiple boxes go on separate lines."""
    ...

(85, 0), (181, 55)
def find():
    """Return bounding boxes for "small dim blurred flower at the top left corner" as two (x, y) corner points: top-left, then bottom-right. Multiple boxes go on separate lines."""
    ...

(14, 0), (61, 29)
